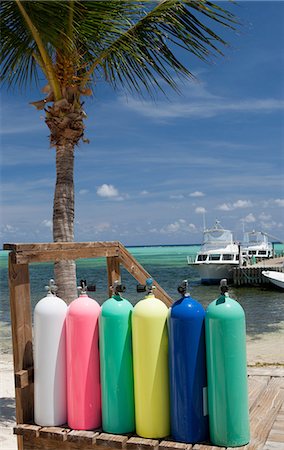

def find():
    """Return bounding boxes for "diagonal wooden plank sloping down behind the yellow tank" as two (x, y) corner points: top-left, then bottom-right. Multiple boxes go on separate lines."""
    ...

(119, 244), (173, 306)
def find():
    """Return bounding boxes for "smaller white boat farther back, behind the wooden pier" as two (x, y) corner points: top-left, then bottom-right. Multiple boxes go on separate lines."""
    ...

(241, 231), (273, 260)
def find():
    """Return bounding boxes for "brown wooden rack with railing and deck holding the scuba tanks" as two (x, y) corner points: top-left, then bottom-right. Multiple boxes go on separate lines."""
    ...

(4, 242), (284, 450)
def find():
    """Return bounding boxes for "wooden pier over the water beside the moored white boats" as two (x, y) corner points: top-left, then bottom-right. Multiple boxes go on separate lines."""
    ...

(233, 257), (284, 287)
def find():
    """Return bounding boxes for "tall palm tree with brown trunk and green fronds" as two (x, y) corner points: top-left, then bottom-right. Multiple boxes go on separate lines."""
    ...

(0, 0), (237, 302)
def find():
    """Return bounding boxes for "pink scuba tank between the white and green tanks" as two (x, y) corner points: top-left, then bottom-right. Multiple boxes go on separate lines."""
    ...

(66, 280), (101, 430)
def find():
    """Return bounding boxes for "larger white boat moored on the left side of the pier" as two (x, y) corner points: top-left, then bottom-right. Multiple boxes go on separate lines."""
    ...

(187, 221), (240, 284)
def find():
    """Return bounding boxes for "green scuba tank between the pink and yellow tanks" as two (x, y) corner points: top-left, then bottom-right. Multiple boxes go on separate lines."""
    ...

(99, 281), (135, 434)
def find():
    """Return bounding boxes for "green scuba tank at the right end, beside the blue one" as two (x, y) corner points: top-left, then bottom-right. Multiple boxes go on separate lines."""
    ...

(205, 280), (250, 447)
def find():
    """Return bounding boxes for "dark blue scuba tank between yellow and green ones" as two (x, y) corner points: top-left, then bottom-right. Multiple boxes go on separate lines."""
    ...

(168, 280), (209, 443)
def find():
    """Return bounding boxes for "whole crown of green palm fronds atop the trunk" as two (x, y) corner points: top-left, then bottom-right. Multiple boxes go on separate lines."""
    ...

(0, 0), (237, 93)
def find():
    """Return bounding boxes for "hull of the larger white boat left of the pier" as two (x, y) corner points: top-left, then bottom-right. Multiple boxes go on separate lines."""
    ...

(193, 263), (238, 284)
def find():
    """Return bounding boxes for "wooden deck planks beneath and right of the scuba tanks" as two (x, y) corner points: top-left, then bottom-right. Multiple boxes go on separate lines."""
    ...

(14, 366), (284, 450)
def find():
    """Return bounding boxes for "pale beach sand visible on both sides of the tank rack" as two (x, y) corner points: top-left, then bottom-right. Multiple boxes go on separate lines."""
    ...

(0, 330), (284, 450)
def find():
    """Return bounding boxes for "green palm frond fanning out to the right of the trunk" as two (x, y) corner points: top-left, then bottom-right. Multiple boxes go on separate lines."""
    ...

(77, 0), (237, 93)
